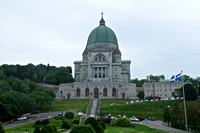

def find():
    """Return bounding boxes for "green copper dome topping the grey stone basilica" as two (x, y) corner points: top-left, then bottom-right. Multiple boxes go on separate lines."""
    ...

(87, 17), (118, 46)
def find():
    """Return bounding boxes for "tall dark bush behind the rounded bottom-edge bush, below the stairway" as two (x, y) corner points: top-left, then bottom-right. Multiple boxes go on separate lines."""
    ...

(84, 117), (103, 133)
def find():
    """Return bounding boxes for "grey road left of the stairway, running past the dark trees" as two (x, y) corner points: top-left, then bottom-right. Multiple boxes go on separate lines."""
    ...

(3, 110), (77, 128)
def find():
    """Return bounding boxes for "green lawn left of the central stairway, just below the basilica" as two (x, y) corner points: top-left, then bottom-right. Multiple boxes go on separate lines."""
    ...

(39, 99), (89, 112)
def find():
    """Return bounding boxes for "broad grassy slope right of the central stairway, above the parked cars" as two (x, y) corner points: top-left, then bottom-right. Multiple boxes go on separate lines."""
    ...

(100, 100), (177, 120)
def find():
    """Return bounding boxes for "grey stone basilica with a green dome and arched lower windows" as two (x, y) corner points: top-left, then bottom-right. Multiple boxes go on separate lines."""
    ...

(57, 16), (136, 99)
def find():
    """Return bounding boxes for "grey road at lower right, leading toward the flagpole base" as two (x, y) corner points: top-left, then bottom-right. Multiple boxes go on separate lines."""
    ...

(134, 120), (188, 133)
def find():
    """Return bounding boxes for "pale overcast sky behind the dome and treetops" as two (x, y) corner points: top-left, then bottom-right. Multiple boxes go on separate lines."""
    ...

(0, 0), (200, 79)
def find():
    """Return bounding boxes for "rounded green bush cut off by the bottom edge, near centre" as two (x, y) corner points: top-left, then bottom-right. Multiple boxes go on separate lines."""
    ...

(69, 125), (95, 133)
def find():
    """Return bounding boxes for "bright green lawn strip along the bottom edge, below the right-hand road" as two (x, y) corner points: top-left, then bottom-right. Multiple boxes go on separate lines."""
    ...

(104, 124), (166, 133)
